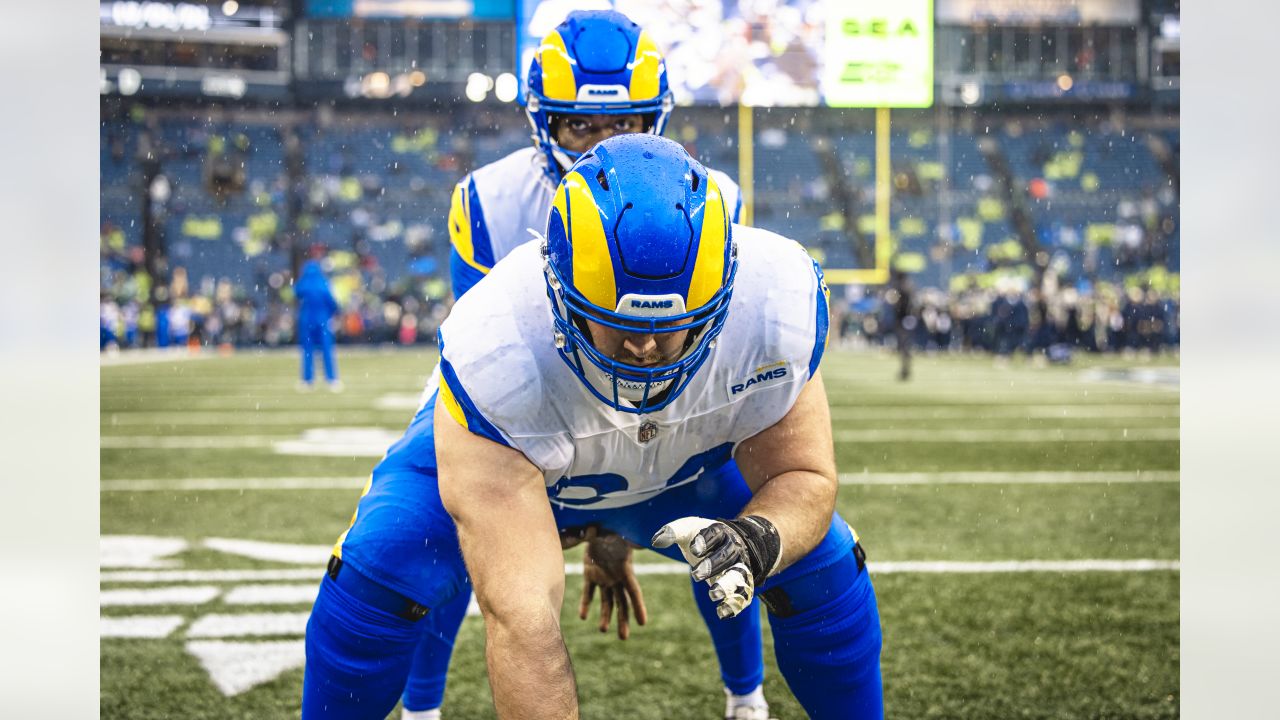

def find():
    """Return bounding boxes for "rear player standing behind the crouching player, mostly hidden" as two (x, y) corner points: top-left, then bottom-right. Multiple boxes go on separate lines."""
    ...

(403, 10), (769, 720)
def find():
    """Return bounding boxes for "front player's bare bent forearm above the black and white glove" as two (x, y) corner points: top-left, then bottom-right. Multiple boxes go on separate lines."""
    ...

(739, 470), (837, 573)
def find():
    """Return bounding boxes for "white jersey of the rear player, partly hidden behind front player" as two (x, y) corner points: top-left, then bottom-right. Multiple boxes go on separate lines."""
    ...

(449, 147), (741, 279)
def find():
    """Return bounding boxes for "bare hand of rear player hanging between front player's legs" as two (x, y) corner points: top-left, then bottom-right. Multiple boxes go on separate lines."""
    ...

(577, 534), (649, 641)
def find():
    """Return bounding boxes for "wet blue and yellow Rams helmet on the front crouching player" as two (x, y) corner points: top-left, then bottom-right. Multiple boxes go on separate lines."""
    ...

(543, 133), (737, 414)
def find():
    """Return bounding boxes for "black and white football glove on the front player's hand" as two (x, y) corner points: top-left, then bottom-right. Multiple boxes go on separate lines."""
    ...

(650, 515), (782, 619)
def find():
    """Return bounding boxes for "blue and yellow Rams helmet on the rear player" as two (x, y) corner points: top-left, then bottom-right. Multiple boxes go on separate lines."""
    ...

(524, 10), (675, 182)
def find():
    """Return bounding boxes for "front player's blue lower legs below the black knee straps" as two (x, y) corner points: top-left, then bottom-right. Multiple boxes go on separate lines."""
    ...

(302, 527), (883, 720)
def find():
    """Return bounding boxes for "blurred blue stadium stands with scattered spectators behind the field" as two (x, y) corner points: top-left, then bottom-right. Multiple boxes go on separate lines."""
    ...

(100, 108), (1179, 352)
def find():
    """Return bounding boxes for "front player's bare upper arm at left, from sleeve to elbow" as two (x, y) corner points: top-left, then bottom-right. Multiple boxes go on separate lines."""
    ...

(435, 392), (564, 621)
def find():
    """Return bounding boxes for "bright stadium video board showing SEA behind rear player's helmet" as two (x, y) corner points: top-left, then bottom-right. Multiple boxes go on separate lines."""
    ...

(516, 0), (933, 108)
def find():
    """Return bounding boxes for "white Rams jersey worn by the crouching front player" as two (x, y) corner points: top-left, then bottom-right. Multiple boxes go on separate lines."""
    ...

(424, 225), (828, 510)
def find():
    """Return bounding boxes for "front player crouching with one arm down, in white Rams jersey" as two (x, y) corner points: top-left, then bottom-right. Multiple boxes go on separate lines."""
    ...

(302, 135), (883, 719)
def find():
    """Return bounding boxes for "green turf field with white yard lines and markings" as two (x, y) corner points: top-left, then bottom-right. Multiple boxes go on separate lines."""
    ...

(101, 348), (1179, 720)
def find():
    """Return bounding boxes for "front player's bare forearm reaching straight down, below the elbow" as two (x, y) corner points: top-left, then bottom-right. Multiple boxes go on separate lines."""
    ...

(485, 609), (577, 720)
